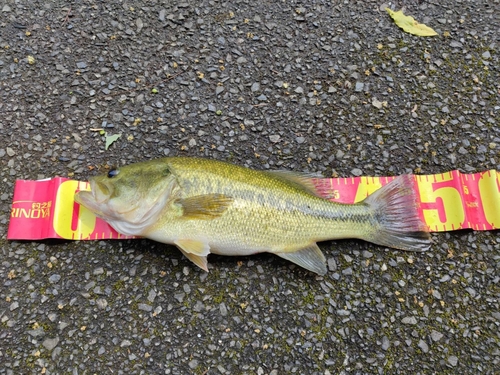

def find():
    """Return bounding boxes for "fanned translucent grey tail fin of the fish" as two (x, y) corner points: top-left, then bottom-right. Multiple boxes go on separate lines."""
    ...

(363, 175), (432, 251)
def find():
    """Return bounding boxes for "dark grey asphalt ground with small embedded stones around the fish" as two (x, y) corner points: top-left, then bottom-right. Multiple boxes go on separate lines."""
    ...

(0, 0), (500, 375)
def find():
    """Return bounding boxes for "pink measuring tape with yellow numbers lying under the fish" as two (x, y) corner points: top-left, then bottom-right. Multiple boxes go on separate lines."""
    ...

(7, 170), (500, 240)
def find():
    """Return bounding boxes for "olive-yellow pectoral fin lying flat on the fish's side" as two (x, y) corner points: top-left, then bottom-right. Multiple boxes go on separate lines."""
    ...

(177, 194), (233, 220)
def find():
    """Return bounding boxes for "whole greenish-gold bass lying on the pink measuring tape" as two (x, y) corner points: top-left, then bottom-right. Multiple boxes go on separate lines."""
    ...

(75, 157), (431, 275)
